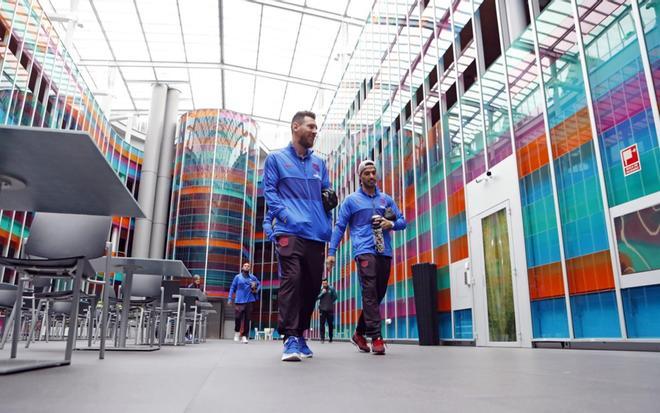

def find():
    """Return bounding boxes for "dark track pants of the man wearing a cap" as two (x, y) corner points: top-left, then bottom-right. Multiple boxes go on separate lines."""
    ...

(355, 254), (392, 338)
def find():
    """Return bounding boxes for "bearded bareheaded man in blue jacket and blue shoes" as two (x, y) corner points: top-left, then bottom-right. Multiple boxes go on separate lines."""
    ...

(264, 111), (331, 361)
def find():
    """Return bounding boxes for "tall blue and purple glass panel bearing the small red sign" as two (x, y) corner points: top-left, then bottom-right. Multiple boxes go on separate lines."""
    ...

(578, 0), (660, 206)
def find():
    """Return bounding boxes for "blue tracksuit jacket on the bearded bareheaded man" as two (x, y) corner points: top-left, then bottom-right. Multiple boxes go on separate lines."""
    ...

(264, 144), (332, 242)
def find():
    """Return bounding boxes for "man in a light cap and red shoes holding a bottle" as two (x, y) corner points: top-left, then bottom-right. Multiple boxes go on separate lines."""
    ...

(326, 160), (406, 355)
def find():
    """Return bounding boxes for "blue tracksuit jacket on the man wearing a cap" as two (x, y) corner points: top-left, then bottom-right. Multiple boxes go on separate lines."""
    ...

(328, 188), (407, 258)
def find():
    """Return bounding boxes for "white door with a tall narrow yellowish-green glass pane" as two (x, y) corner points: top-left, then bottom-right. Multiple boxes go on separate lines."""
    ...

(470, 201), (521, 347)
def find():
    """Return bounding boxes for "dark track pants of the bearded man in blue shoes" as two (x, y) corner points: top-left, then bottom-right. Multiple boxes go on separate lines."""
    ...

(276, 235), (325, 337)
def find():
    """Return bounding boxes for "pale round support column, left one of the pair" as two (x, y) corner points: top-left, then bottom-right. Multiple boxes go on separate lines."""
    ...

(131, 83), (167, 258)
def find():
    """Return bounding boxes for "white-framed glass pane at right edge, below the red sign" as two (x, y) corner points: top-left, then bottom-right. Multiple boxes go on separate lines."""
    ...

(614, 204), (660, 275)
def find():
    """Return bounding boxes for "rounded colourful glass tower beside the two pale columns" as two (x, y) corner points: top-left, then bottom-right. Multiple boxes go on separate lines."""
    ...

(167, 109), (260, 297)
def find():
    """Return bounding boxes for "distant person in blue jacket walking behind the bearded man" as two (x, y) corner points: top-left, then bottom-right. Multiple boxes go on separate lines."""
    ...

(227, 262), (261, 344)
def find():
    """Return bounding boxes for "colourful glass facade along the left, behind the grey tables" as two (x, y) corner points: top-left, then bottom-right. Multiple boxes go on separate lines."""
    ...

(0, 0), (142, 282)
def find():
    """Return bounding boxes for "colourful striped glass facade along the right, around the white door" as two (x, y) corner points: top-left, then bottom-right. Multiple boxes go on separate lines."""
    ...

(319, 0), (660, 345)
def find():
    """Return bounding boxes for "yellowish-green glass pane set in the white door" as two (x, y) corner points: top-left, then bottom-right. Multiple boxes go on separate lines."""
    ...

(481, 209), (517, 341)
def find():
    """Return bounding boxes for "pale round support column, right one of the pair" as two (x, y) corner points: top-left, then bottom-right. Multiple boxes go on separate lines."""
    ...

(149, 88), (181, 258)
